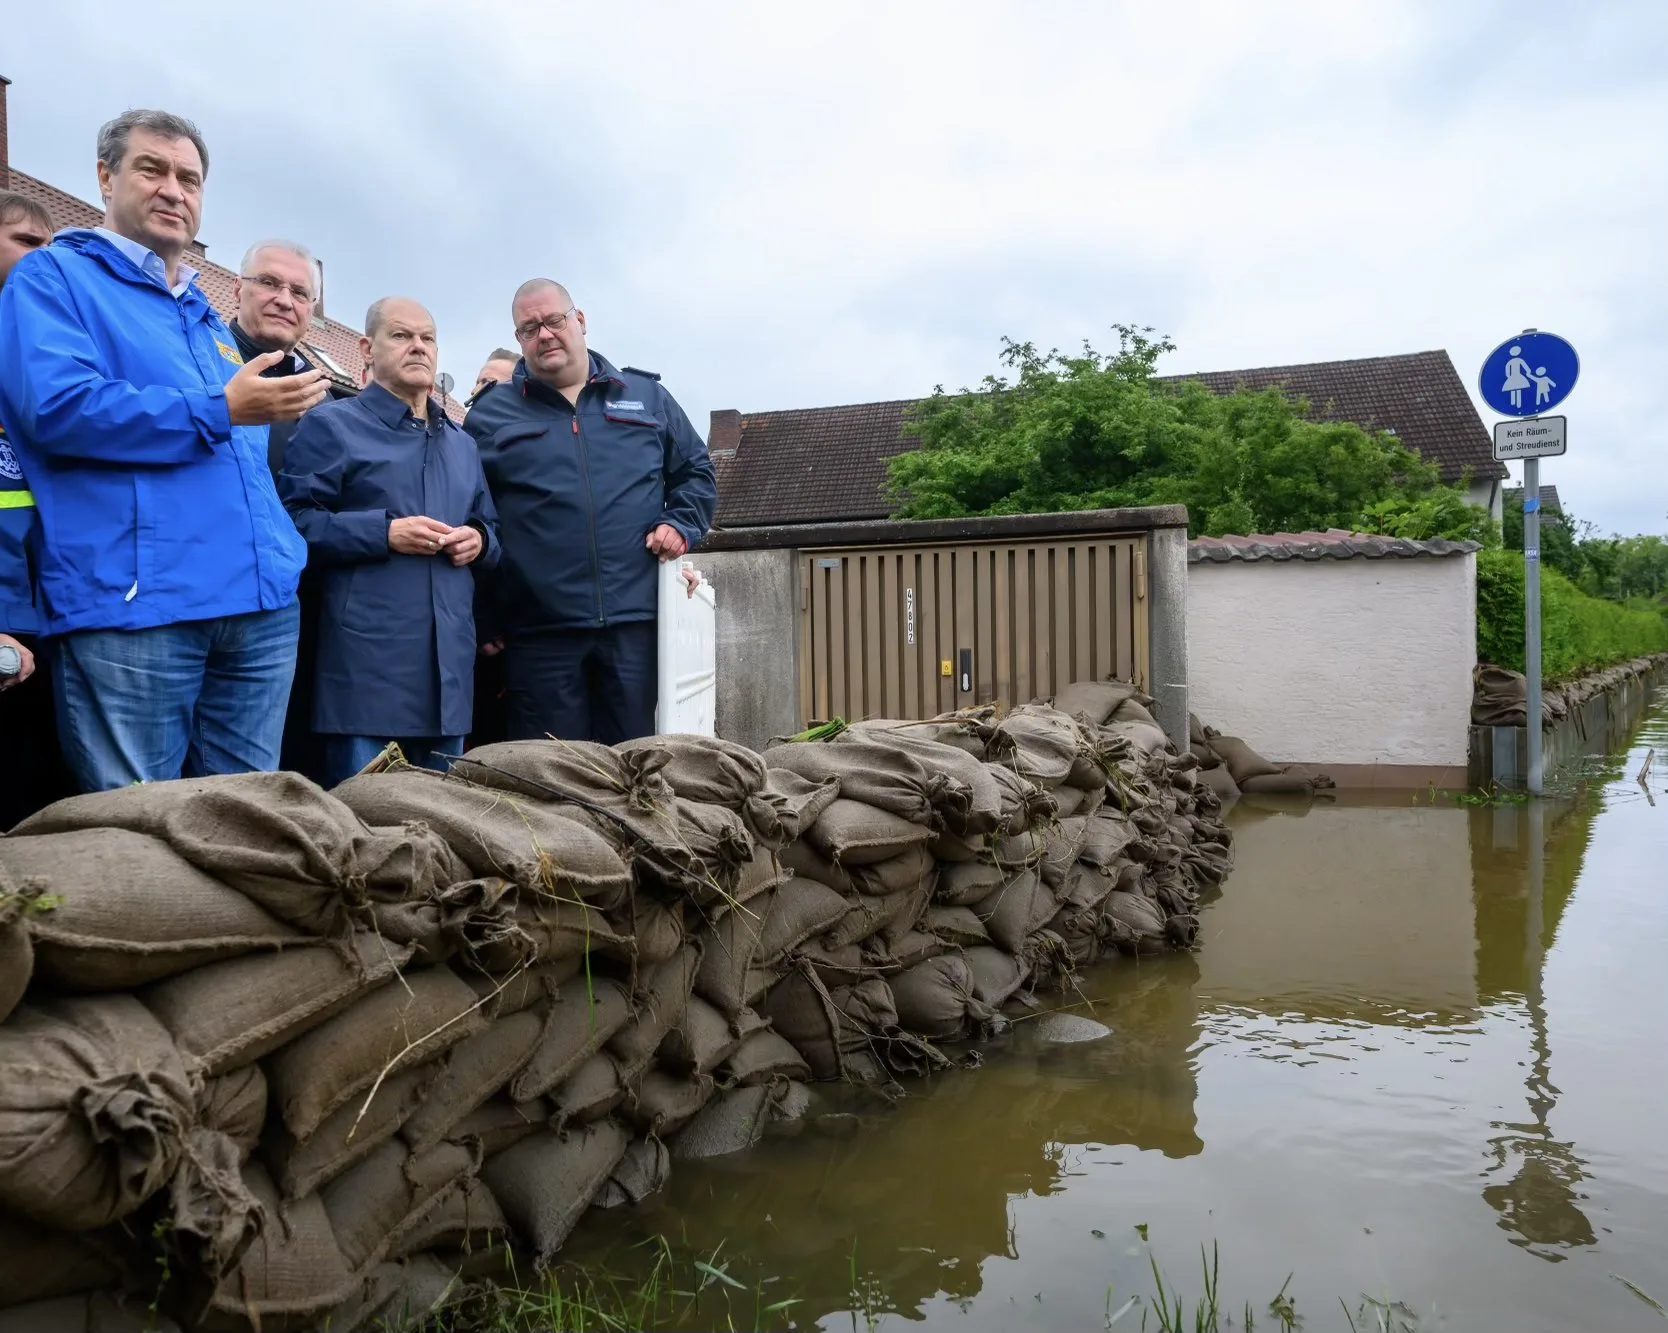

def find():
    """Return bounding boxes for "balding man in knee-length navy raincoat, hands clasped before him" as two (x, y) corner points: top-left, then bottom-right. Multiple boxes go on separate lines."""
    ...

(279, 297), (499, 786)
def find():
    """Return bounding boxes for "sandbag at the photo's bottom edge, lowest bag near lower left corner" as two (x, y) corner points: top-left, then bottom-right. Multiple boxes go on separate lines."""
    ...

(193, 1159), (355, 1330)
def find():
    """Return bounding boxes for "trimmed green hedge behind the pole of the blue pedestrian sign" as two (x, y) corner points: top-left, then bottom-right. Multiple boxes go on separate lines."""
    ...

(1476, 551), (1668, 681)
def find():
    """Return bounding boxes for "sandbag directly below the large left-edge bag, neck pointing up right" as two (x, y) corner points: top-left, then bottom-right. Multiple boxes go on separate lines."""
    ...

(138, 934), (410, 1076)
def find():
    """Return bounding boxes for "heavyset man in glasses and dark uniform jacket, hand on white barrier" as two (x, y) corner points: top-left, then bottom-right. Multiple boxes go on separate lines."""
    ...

(465, 279), (717, 744)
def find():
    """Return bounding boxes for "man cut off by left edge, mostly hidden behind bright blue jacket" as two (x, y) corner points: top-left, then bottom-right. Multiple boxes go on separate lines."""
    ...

(0, 190), (68, 831)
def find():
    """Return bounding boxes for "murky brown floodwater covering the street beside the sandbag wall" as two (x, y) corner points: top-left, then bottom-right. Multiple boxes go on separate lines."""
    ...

(575, 699), (1668, 1333)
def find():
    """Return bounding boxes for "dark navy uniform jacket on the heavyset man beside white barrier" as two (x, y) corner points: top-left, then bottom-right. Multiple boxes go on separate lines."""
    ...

(464, 352), (717, 634)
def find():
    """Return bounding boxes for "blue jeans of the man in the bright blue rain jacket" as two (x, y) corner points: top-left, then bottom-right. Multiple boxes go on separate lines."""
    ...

(52, 602), (299, 791)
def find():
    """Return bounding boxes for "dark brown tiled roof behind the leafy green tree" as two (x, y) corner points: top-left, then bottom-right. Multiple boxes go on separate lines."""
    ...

(712, 352), (1506, 527)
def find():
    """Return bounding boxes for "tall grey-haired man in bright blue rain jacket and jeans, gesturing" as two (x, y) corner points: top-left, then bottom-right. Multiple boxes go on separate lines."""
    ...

(0, 110), (327, 791)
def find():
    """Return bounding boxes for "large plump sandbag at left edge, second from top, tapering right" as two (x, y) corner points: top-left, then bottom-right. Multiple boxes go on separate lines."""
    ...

(0, 829), (307, 991)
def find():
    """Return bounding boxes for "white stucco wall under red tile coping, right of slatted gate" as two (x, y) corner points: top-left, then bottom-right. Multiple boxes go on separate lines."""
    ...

(1188, 556), (1476, 766)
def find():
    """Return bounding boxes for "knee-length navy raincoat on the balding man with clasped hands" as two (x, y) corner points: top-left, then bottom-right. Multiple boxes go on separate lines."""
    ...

(279, 384), (499, 739)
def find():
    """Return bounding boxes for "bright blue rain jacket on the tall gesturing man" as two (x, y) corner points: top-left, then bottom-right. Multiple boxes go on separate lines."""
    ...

(0, 230), (307, 634)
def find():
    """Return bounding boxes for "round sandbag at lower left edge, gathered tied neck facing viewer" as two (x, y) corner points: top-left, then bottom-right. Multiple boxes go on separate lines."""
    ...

(0, 996), (197, 1231)
